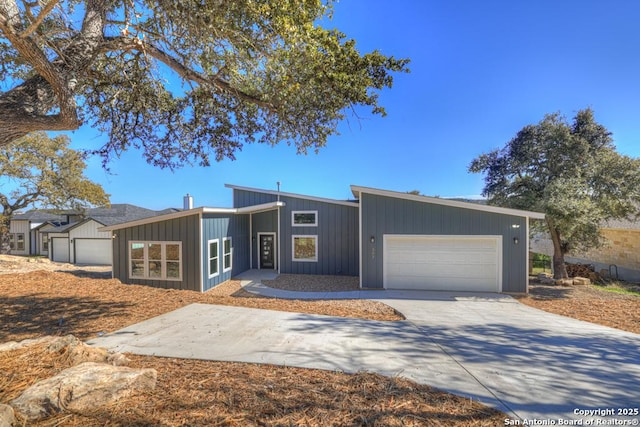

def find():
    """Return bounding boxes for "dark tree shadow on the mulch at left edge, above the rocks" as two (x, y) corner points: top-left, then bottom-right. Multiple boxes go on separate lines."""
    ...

(0, 294), (133, 342)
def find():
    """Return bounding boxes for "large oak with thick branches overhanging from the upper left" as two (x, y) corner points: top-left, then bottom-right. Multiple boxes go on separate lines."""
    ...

(0, 0), (408, 167)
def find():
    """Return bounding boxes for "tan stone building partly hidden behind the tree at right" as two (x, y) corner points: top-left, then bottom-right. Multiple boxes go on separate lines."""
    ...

(531, 220), (640, 282)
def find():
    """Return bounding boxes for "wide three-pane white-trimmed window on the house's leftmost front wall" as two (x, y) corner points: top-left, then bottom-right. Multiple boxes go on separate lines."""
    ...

(129, 241), (182, 280)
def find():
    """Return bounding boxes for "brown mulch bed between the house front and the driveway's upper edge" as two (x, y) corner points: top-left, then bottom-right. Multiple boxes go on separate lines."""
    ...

(0, 271), (403, 342)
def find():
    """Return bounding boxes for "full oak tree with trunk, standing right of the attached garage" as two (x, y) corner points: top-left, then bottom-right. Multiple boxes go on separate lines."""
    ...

(469, 109), (640, 278)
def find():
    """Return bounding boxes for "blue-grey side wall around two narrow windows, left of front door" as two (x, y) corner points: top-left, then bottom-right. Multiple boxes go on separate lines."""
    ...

(201, 214), (249, 291)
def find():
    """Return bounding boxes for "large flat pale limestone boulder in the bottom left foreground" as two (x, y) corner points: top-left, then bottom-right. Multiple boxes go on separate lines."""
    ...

(11, 362), (157, 421)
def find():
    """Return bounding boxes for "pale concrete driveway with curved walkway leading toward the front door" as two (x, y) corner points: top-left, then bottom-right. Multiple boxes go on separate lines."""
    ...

(89, 284), (640, 425)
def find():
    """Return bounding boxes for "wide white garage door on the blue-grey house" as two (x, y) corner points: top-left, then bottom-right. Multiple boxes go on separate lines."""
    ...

(383, 235), (502, 292)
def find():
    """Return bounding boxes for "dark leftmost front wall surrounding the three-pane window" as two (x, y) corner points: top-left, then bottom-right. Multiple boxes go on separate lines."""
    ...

(112, 214), (202, 291)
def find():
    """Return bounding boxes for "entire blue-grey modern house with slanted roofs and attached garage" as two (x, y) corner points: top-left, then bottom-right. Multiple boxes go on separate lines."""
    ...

(101, 185), (544, 293)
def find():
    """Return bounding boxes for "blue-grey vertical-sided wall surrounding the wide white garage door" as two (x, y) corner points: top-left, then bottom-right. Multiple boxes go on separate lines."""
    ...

(360, 193), (528, 292)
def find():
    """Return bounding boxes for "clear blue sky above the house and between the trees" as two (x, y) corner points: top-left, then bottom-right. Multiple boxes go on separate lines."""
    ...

(66, 0), (640, 209)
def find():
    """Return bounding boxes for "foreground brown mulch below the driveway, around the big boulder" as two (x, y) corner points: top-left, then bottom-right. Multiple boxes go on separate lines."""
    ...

(0, 345), (506, 426)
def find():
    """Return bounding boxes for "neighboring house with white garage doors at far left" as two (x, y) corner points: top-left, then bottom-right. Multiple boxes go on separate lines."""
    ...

(10, 204), (176, 265)
